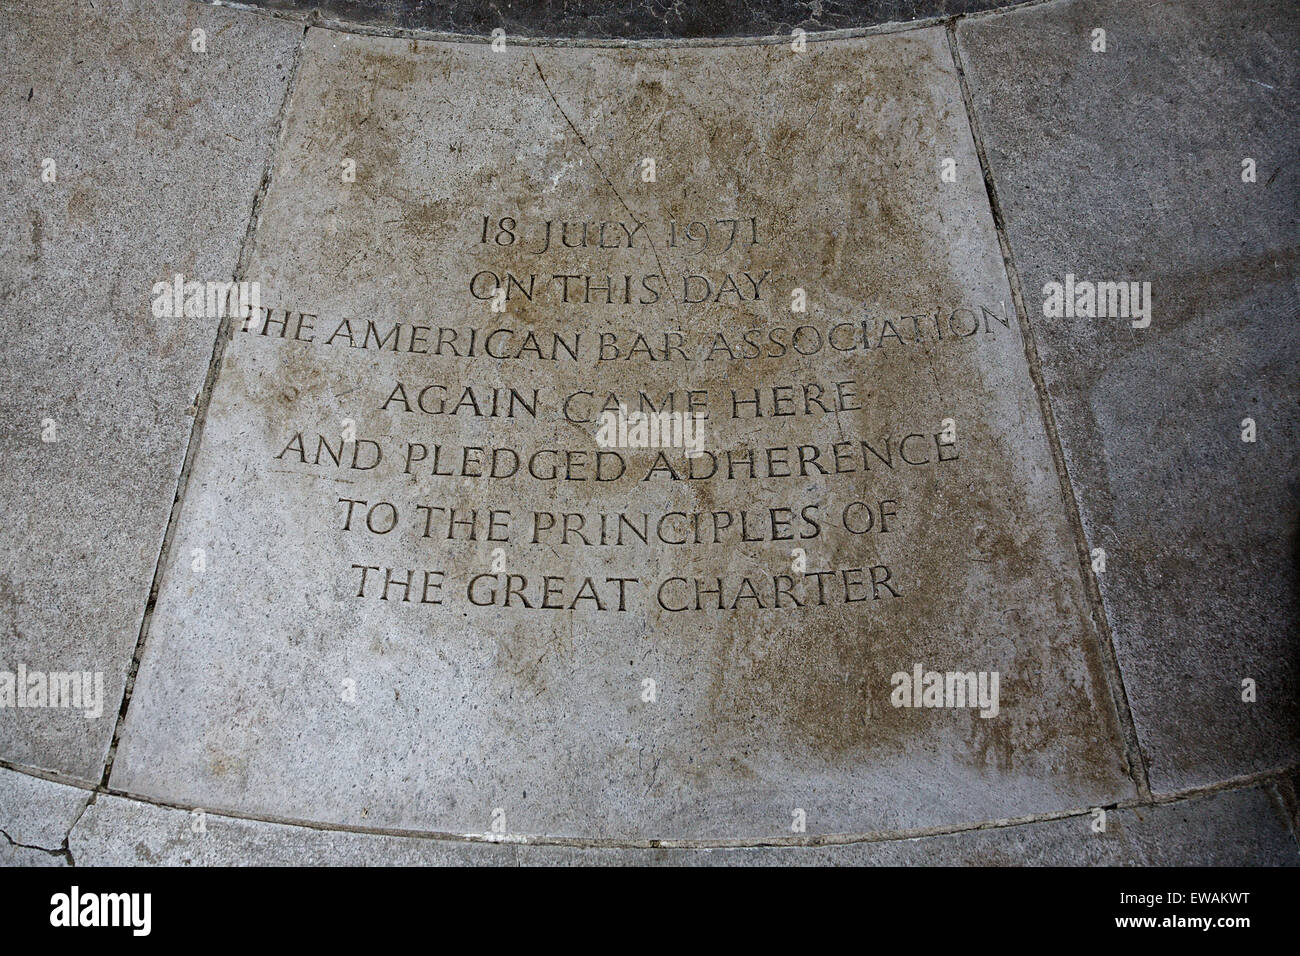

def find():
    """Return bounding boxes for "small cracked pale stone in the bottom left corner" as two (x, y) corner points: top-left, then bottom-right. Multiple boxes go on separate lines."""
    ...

(0, 767), (90, 866)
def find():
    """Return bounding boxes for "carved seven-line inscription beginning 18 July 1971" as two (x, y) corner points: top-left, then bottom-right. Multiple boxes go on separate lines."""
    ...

(239, 213), (1010, 615)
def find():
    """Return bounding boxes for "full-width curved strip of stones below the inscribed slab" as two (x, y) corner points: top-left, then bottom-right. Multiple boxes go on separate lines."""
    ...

(0, 767), (1300, 866)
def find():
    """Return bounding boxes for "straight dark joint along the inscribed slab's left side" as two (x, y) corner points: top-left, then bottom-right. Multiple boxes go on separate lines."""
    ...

(100, 17), (312, 790)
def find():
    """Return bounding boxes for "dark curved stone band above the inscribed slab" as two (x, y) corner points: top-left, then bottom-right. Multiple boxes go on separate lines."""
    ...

(231, 0), (1023, 40)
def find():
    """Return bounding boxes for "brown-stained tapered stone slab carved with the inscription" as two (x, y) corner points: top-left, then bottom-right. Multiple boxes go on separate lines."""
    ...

(111, 30), (1134, 839)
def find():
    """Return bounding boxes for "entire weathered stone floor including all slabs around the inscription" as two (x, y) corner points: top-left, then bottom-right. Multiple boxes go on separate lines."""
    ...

(0, 0), (1300, 865)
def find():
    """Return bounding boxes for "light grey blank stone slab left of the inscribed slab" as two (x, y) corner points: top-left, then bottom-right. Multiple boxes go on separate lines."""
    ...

(0, 0), (300, 782)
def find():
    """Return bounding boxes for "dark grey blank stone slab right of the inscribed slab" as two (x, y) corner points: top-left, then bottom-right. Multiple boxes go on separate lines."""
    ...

(958, 0), (1300, 791)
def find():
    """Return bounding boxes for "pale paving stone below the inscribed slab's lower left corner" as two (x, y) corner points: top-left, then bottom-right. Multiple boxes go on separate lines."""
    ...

(69, 796), (515, 866)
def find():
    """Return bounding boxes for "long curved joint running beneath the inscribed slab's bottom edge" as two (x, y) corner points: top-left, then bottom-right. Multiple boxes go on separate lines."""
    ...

(0, 760), (1300, 849)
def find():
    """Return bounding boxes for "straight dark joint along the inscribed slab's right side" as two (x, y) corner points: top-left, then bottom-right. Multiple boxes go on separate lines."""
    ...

(946, 20), (1152, 797)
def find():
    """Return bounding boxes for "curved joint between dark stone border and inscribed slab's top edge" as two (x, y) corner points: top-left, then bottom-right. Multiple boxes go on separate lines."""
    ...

(191, 0), (1067, 49)
